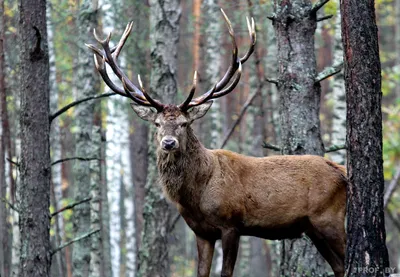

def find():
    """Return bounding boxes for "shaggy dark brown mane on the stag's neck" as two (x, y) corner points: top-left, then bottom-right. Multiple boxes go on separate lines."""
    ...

(157, 127), (212, 206)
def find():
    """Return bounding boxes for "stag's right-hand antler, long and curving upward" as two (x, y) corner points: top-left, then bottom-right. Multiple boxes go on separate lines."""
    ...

(179, 9), (256, 111)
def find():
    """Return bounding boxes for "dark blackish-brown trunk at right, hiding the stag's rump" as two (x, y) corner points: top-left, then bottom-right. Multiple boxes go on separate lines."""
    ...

(340, 0), (389, 277)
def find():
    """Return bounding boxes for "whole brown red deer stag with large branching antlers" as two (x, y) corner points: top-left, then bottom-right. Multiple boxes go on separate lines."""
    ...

(87, 11), (347, 277)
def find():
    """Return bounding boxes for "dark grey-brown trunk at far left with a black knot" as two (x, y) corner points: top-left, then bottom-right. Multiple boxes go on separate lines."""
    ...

(18, 0), (51, 277)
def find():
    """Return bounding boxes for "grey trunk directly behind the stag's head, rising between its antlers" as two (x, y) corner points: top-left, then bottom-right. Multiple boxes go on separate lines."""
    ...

(138, 0), (181, 277)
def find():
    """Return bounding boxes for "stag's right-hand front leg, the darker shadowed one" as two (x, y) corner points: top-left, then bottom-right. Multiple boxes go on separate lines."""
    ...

(221, 230), (240, 277)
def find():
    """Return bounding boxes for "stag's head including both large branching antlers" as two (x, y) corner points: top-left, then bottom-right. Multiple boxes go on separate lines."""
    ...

(86, 9), (256, 151)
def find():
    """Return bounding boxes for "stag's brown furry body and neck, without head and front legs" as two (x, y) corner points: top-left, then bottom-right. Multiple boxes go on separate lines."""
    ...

(157, 125), (347, 276)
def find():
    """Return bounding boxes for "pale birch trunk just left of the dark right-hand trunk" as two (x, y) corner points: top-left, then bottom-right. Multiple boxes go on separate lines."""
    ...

(330, 0), (346, 164)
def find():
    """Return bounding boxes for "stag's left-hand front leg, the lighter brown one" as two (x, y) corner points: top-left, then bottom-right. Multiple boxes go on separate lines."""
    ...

(196, 236), (215, 277)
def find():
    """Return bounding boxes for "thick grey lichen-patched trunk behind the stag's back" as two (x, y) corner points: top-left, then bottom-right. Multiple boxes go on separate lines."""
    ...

(273, 0), (326, 276)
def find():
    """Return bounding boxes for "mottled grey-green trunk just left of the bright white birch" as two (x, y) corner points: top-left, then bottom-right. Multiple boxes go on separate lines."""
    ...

(72, 0), (100, 277)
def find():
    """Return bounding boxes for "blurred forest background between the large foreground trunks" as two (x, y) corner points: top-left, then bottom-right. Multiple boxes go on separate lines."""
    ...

(0, 0), (400, 277)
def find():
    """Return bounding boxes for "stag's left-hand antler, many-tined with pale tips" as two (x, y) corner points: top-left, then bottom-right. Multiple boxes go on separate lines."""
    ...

(86, 22), (165, 111)
